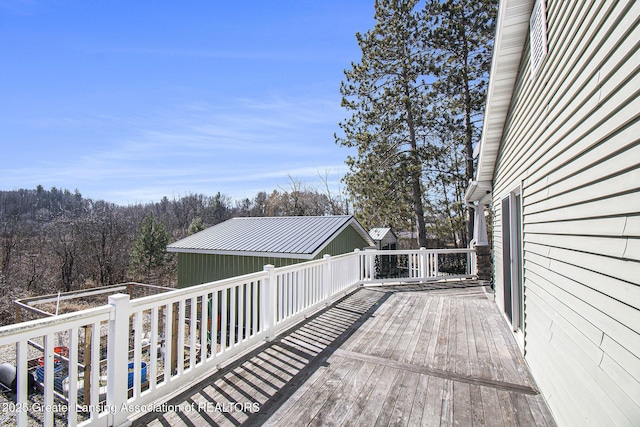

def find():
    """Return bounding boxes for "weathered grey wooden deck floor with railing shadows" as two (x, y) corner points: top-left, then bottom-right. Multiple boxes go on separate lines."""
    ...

(134, 281), (555, 427)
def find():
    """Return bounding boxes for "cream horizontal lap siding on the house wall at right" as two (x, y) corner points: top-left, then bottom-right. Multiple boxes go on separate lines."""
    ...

(492, 0), (640, 425)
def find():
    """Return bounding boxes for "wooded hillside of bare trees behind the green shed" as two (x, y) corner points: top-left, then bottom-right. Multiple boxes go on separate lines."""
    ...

(0, 185), (348, 324)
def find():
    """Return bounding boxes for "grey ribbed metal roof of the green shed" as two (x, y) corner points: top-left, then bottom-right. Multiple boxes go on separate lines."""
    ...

(167, 215), (373, 259)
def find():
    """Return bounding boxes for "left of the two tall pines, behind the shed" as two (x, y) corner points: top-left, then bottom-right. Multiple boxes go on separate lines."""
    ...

(336, 0), (427, 246)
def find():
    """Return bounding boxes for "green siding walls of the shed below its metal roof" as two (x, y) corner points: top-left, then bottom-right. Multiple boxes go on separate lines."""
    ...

(178, 222), (369, 288)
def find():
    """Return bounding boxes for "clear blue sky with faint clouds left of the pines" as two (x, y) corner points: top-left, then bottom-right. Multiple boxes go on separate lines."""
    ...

(0, 0), (374, 204)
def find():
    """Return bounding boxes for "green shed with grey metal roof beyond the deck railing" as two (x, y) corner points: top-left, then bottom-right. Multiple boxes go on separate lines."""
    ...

(167, 215), (374, 288)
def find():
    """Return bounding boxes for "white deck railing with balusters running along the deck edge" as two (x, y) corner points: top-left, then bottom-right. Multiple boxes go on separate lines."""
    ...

(0, 249), (475, 426)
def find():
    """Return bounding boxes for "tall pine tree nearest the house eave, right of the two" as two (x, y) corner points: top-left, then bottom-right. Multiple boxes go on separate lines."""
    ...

(421, 0), (497, 244)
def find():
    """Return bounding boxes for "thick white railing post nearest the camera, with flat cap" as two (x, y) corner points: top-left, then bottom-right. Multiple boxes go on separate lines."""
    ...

(107, 294), (130, 426)
